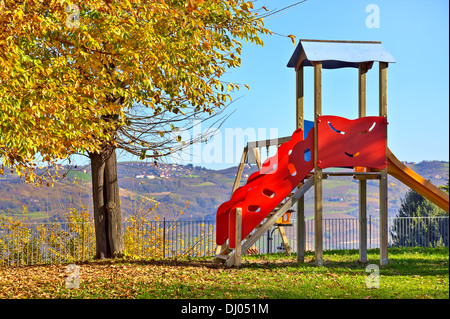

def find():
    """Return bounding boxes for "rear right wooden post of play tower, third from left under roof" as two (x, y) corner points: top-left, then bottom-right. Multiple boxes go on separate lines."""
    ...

(358, 63), (368, 263)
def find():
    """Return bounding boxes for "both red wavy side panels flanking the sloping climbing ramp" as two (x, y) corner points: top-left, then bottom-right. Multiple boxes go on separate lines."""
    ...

(216, 129), (314, 248)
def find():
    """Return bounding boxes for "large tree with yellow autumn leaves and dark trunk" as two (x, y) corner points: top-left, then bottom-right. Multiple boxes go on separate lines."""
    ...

(0, 0), (306, 258)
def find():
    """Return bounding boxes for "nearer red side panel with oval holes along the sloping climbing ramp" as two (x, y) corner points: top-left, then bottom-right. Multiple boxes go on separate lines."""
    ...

(228, 130), (314, 248)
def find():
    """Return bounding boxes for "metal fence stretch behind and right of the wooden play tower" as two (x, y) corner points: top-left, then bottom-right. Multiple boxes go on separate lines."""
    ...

(255, 216), (449, 253)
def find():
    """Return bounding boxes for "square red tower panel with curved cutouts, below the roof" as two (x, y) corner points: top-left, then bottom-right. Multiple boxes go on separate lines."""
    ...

(317, 115), (387, 169)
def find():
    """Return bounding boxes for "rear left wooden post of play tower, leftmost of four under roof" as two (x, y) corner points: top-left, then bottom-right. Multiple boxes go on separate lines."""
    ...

(295, 64), (306, 263)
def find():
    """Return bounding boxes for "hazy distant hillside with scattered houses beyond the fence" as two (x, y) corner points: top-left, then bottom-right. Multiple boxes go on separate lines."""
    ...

(0, 161), (449, 221)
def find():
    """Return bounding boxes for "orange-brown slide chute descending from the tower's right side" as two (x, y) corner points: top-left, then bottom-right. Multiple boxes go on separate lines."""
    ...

(387, 149), (449, 213)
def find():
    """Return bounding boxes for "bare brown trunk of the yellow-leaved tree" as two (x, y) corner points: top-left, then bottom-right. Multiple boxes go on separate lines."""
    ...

(89, 147), (123, 259)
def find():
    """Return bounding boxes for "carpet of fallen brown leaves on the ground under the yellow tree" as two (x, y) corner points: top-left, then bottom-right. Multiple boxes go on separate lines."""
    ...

(0, 261), (232, 298)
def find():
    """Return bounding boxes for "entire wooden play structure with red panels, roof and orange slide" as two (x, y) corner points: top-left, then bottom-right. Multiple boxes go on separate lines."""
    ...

(215, 40), (449, 266)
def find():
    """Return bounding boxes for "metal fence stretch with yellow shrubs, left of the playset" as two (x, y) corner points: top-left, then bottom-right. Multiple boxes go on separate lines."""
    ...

(0, 219), (215, 266)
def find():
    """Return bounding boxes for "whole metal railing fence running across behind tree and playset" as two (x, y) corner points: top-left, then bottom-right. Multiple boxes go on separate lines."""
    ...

(0, 216), (449, 266)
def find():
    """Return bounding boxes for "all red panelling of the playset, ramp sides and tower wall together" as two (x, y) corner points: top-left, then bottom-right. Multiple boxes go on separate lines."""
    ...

(216, 116), (387, 248)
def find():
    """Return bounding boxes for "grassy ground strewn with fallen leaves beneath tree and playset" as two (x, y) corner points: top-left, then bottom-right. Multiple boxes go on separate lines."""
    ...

(0, 248), (449, 299)
